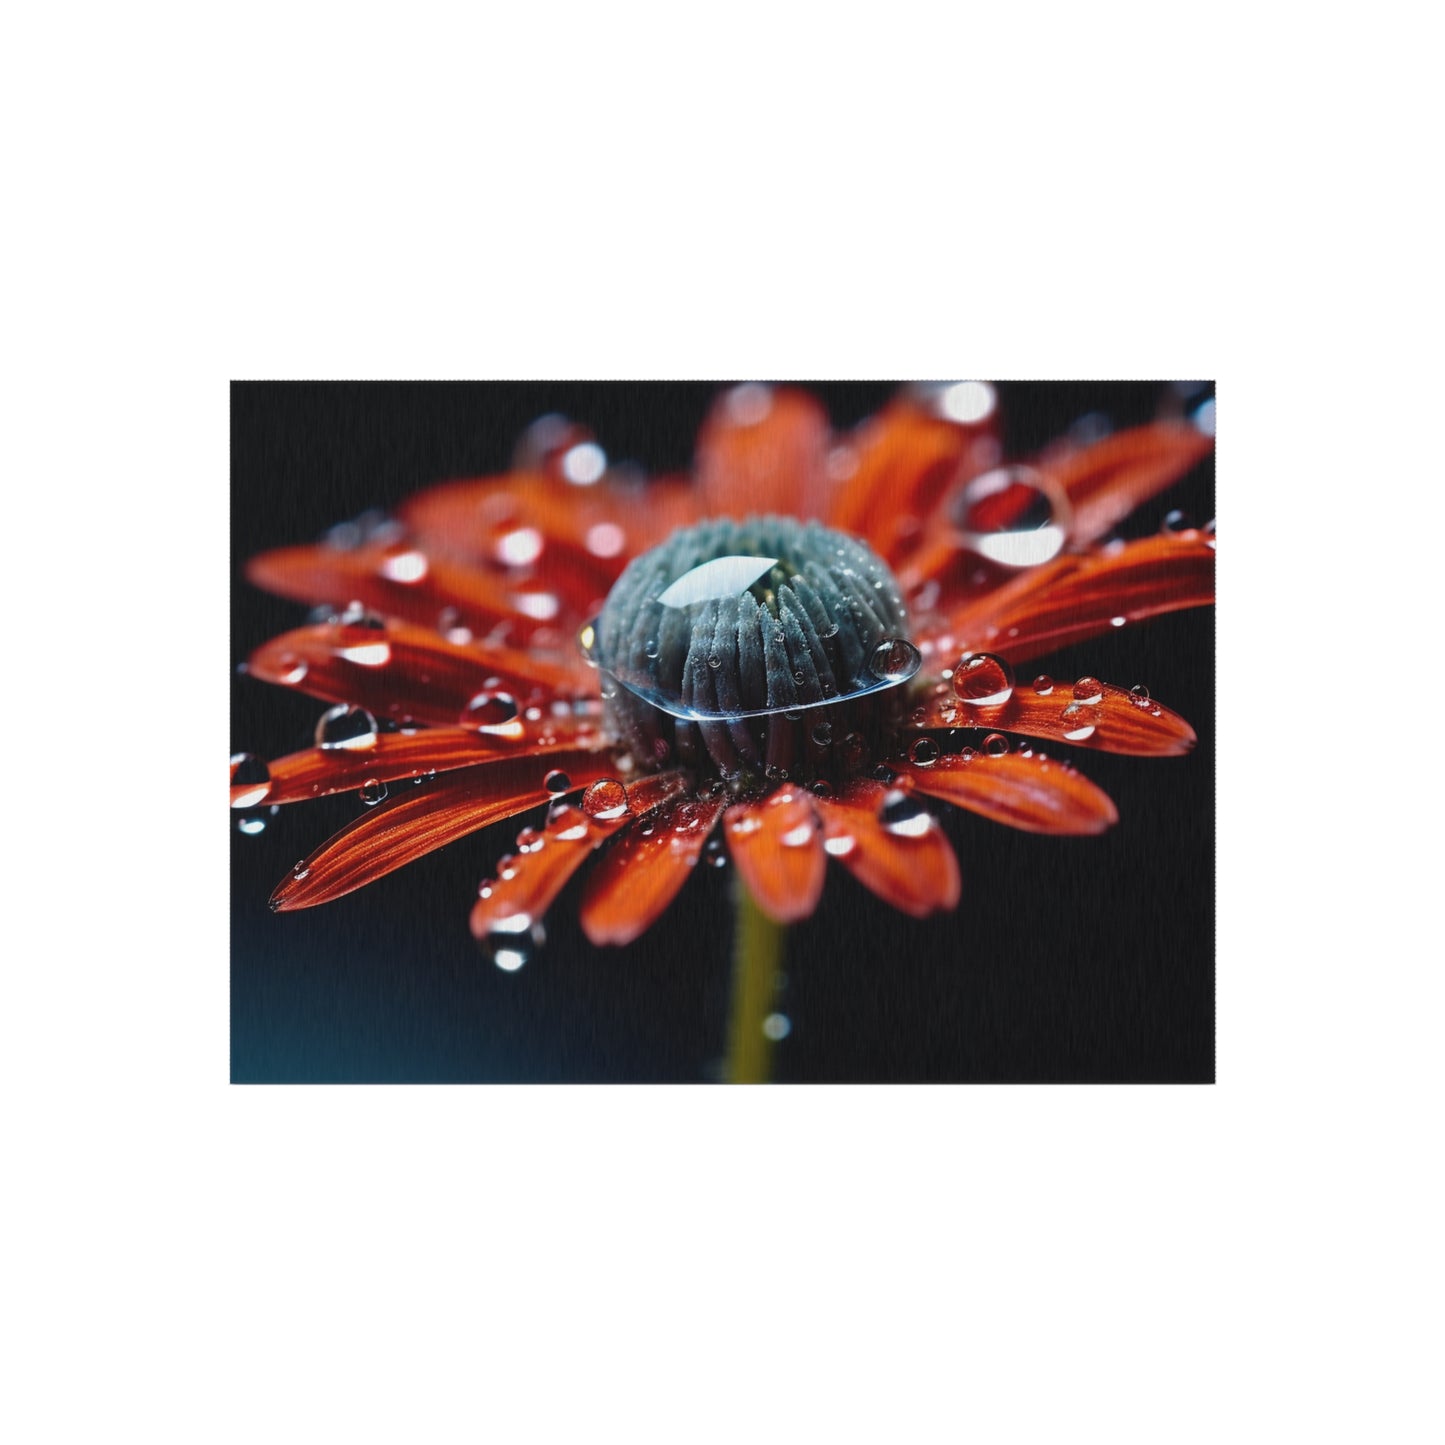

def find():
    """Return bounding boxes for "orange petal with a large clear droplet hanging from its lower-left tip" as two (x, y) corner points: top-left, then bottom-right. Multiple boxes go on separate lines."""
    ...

(471, 773), (686, 938)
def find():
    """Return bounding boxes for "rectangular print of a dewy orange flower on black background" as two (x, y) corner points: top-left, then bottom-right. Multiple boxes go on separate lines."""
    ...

(230, 381), (1215, 1084)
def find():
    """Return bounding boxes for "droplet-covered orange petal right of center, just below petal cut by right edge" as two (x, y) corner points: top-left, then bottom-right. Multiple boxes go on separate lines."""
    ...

(910, 682), (1198, 757)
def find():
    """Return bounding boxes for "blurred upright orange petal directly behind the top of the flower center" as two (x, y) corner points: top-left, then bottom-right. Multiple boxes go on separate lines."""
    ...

(696, 383), (831, 517)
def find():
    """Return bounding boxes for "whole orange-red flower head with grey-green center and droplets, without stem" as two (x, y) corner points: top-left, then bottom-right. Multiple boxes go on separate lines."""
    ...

(231, 383), (1214, 948)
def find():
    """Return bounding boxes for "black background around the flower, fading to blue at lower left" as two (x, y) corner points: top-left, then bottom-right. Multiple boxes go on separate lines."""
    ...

(231, 383), (1214, 1082)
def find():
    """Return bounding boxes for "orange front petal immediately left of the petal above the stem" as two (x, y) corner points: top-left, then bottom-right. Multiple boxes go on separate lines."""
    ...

(579, 798), (723, 945)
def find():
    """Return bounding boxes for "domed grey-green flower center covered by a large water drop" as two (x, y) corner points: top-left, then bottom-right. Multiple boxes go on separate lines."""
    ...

(584, 517), (919, 789)
